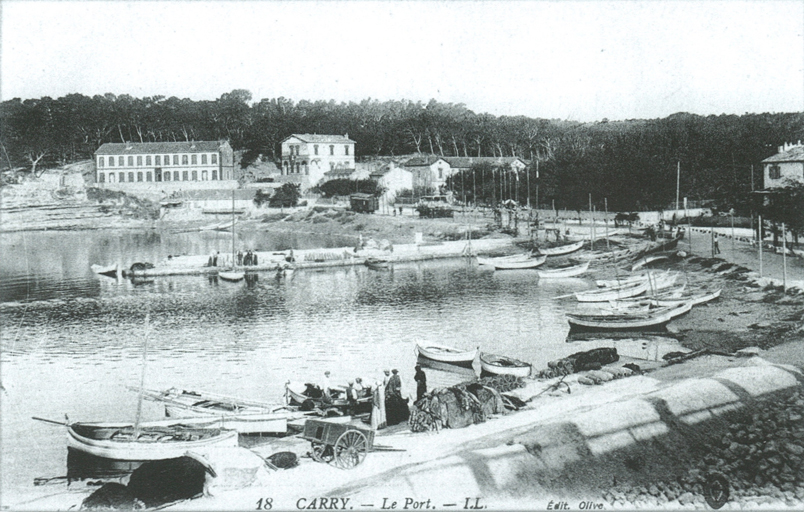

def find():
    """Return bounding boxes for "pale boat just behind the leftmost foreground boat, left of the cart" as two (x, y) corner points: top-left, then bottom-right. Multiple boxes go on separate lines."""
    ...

(138, 389), (298, 434)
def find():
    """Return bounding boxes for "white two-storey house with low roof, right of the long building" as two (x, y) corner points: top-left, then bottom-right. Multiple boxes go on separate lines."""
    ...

(282, 133), (355, 188)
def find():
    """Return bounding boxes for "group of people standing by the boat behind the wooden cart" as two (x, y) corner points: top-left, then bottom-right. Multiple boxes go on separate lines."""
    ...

(320, 364), (427, 429)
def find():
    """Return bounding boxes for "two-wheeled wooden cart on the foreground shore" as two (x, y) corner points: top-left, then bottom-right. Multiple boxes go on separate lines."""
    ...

(302, 419), (374, 469)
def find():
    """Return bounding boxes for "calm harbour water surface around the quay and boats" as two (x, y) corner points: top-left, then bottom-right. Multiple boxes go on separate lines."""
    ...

(0, 231), (668, 504)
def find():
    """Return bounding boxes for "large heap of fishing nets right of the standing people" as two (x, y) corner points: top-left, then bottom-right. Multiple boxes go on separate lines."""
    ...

(409, 375), (524, 432)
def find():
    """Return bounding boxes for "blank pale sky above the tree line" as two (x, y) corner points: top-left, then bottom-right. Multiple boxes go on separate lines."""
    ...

(0, 0), (804, 122)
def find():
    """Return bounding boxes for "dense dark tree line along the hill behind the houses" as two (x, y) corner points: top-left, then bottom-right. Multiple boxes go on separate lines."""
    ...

(0, 90), (804, 210)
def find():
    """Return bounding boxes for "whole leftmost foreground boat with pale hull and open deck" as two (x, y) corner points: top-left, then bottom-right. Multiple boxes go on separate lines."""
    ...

(67, 420), (237, 461)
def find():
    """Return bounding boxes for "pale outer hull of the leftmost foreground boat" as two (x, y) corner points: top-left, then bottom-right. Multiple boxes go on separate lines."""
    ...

(67, 422), (238, 461)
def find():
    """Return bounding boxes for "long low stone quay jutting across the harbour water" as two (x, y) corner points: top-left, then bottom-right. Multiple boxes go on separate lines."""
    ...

(123, 238), (524, 277)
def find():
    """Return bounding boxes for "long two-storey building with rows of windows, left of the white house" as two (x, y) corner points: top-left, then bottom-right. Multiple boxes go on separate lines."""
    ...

(95, 141), (237, 192)
